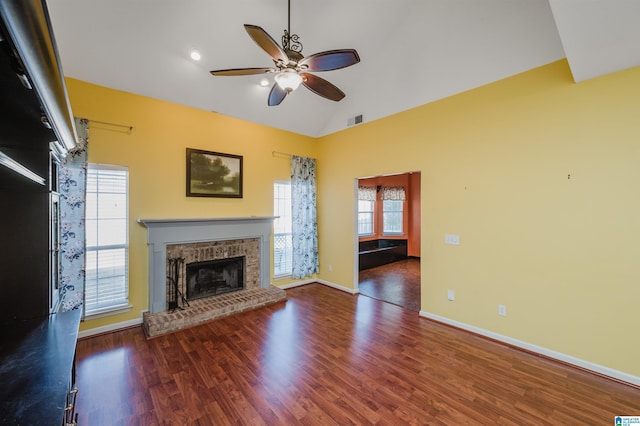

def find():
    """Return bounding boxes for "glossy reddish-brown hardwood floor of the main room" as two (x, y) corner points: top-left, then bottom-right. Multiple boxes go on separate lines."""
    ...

(77, 284), (640, 426)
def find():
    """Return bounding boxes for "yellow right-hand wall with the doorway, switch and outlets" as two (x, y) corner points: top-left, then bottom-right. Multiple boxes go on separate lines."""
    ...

(318, 61), (640, 376)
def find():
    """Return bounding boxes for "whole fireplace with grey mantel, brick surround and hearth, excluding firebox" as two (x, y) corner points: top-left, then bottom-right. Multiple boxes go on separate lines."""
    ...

(138, 217), (287, 338)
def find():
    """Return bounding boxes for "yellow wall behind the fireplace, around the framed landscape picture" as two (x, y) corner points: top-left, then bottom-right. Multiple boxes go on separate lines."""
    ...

(67, 79), (317, 330)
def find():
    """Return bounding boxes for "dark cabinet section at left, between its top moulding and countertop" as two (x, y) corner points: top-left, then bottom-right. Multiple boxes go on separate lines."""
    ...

(0, 0), (64, 322)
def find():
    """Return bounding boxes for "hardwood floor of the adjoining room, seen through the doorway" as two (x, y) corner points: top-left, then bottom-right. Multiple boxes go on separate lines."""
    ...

(358, 258), (420, 312)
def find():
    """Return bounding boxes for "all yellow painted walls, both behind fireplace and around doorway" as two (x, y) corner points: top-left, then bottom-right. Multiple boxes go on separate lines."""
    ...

(68, 61), (640, 376)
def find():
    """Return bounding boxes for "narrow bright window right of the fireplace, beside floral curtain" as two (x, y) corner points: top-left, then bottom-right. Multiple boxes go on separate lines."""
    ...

(273, 182), (293, 277)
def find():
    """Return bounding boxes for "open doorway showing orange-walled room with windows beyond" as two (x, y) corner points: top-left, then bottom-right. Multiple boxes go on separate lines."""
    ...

(355, 172), (421, 312)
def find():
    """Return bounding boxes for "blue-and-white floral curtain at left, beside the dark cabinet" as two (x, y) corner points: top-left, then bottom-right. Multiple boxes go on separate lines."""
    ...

(58, 118), (89, 311)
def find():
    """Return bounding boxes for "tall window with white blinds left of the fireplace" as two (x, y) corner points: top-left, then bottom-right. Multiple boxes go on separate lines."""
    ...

(85, 164), (129, 316)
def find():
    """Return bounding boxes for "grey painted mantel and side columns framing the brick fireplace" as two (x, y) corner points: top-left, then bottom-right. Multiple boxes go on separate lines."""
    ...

(138, 216), (274, 313)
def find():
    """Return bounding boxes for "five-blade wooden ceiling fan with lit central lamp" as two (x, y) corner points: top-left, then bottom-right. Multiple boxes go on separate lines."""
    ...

(211, 0), (360, 106)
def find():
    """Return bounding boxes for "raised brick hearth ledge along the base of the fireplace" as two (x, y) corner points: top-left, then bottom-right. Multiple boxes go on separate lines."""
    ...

(144, 286), (287, 338)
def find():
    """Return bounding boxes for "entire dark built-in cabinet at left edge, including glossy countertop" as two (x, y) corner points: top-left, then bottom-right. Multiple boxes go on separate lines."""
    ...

(0, 0), (81, 425)
